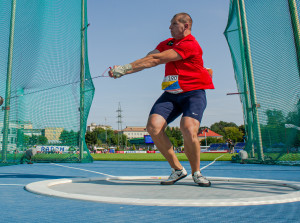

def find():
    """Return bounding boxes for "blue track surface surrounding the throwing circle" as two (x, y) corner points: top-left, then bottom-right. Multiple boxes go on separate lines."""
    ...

(0, 161), (300, 223)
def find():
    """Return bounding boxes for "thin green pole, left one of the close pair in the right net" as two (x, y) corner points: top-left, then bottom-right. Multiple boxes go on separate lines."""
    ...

(236, 1), (254, 158)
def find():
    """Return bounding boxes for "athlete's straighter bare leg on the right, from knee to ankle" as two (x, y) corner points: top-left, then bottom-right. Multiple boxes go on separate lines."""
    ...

(180, 117), (200, 174)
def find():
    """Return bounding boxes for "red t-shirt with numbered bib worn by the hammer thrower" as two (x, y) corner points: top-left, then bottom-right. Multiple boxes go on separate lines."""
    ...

(156, 35), (215, 94)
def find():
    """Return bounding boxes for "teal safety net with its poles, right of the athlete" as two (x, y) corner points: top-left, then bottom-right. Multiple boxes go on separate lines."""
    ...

(224, 0), (300, 165)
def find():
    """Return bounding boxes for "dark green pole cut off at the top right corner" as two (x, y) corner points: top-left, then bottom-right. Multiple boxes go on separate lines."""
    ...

(289, 0), (300, 75)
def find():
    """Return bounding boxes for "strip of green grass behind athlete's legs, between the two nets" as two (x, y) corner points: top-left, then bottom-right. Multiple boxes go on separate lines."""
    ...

(91, 153), (235, 161)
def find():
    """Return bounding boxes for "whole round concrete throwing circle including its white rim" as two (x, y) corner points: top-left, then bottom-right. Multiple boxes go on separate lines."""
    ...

(25, 176), (300, 207)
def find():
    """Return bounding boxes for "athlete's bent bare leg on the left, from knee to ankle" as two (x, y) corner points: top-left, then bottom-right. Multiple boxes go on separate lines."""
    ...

(147, 114), (182, 169)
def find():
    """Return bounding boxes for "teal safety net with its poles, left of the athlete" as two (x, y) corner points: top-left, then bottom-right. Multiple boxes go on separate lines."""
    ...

(0, 0), (94, 165)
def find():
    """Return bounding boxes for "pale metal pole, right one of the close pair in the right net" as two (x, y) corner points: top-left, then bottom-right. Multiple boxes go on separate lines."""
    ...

(239, 0), (264, 162)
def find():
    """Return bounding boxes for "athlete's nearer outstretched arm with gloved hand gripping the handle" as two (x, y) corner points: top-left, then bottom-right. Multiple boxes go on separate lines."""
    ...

(108, 49), (182, 78)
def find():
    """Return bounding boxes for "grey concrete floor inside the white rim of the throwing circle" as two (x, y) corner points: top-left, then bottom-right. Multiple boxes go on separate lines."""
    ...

(50, 179), (295, 200)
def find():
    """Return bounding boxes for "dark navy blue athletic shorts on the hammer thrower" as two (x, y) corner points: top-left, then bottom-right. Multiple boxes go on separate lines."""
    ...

(150, 90), (206, 124)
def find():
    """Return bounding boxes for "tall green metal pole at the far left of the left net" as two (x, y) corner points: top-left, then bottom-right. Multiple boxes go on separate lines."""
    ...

(2, 0), (17, 163)
